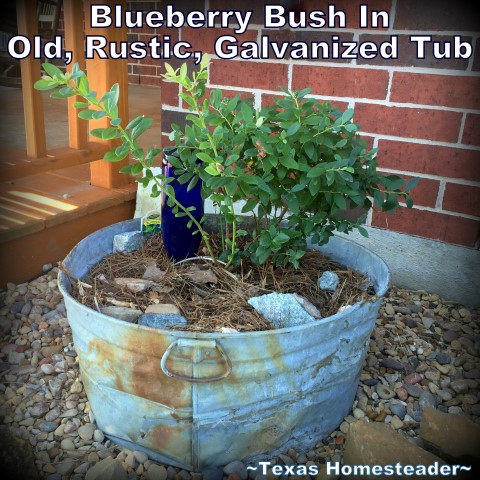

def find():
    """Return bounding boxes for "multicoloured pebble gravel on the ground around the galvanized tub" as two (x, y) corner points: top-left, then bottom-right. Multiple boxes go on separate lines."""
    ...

(0, 266), (480, 480)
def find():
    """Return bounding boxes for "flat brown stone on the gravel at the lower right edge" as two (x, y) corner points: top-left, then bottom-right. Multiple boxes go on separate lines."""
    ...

(420, 408), (480, 462)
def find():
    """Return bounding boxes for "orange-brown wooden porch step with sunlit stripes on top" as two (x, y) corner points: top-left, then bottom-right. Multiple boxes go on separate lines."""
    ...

(0, 164), (136, 287)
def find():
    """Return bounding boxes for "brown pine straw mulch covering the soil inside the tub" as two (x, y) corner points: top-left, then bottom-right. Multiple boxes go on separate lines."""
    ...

(65, 235), (375, 332)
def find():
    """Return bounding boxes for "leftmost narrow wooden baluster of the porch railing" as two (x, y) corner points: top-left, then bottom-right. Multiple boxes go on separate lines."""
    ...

(17, 0), (47, 158)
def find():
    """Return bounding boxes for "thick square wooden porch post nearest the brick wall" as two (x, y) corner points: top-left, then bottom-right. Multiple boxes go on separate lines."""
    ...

(85, 0), (129, 188)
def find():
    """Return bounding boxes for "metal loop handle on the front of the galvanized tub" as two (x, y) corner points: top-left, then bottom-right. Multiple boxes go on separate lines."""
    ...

(160, 338), (232, 383)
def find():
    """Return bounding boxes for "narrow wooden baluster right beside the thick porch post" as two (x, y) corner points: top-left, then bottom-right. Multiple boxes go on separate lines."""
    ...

(63, 0), (87, 149)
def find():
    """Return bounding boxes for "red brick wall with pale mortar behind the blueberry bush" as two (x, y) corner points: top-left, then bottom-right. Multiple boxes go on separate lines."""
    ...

(125, 0), (480, 247)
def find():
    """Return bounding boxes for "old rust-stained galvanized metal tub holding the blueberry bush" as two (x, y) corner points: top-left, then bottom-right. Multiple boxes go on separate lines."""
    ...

(59, 220), (389, 471)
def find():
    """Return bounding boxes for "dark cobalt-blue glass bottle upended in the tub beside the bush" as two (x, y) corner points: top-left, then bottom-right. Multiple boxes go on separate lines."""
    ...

(162, 151), (204, 261)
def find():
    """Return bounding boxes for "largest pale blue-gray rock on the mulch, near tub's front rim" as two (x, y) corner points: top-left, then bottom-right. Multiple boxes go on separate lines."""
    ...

(248, 293), (316, 328)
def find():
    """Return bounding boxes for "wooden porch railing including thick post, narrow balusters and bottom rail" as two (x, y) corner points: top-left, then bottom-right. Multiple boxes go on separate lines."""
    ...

(14, 0), (129, 188)
